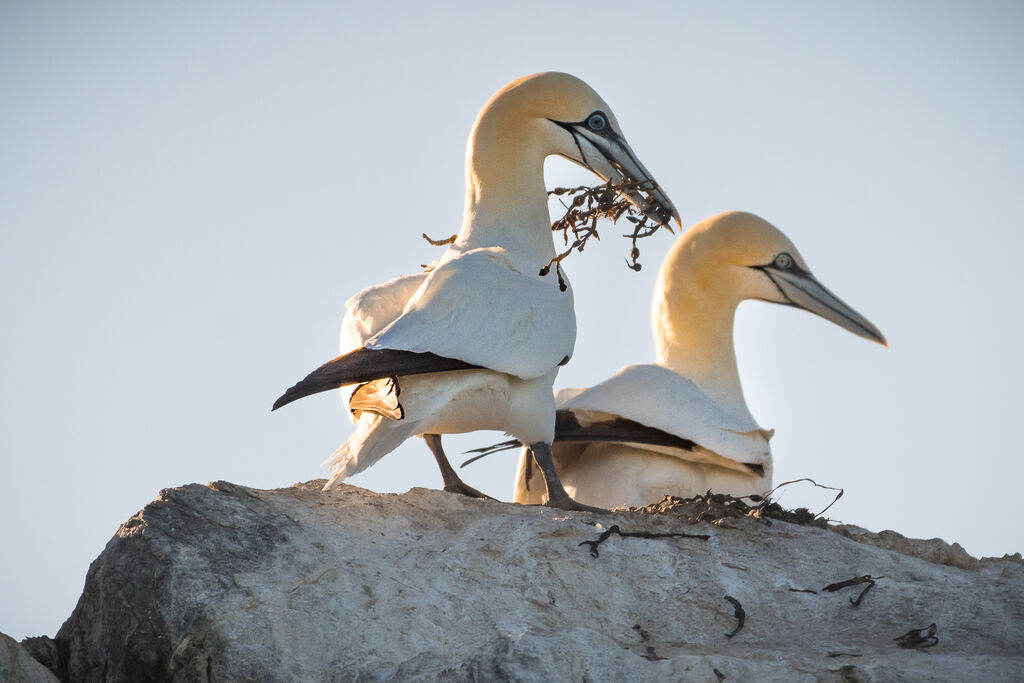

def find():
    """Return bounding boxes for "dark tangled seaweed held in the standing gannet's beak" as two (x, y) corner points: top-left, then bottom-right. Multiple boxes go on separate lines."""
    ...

(540, 179), (672, 292)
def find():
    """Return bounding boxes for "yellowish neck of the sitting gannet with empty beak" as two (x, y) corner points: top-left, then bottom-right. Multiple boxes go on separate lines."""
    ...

(651, 260), (754, 421)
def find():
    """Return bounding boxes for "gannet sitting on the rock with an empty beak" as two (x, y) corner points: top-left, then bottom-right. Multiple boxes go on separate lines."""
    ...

(505, 212), (886, 508)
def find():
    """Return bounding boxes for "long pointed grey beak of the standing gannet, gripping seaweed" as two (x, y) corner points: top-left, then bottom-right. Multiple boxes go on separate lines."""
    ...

(555, 122), (683, 229)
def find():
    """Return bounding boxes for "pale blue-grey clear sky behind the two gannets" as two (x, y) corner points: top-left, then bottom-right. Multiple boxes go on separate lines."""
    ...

(0, 1), (1024, 638)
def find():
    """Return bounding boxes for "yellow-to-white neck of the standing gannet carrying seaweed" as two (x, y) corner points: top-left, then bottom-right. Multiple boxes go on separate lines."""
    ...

(456, 112), (555, 272)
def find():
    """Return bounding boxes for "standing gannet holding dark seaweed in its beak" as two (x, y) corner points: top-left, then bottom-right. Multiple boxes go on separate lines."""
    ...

(273, 73), (679, 509)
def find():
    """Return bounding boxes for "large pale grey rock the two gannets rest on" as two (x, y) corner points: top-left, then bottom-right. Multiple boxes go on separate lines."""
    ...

(34, 481), (1024, 683)
